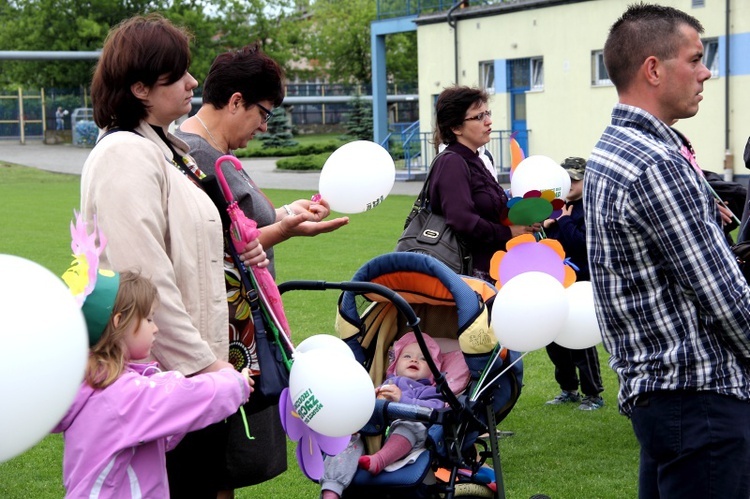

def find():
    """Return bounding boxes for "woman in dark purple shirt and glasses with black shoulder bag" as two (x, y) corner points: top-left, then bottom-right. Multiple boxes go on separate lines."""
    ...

(430, 86), (541, 282)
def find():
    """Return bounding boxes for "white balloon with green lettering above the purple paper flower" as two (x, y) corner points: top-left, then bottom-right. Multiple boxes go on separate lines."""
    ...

(289, 348), (375, 437)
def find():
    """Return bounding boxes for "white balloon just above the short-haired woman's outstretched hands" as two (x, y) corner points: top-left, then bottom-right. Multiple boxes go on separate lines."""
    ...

(318, 140), (396, 213)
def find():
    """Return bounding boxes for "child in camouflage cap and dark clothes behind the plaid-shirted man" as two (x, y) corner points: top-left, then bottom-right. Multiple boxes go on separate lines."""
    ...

(543, 157), (604, 411)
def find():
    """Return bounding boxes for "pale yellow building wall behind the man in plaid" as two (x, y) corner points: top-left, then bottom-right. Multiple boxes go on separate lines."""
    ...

(417, 0), (750, 175)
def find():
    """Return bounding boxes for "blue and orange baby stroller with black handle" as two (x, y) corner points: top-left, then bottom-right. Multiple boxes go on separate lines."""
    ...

(279, 252), (523, 498)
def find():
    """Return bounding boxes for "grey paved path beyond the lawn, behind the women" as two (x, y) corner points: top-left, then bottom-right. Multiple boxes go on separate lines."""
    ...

(0, 140), (422, 196)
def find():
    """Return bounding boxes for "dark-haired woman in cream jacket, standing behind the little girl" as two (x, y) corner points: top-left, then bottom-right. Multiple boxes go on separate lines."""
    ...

(81, 15), (268, 498)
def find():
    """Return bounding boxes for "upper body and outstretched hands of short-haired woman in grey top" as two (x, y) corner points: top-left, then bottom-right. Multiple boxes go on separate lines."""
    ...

(176, 44), (349, 276)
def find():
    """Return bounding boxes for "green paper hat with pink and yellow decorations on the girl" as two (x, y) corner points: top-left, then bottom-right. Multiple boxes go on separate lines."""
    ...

(62, 213), (120, 346)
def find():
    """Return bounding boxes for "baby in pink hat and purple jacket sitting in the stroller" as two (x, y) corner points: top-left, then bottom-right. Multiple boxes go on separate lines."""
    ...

(321, 332), (445, 499)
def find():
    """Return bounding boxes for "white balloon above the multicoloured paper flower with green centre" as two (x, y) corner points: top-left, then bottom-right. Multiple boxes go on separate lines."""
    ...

(510, 155), (570, 199)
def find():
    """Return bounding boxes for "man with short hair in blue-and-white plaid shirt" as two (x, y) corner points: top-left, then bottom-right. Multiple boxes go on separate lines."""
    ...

(583, 4), (750, 498)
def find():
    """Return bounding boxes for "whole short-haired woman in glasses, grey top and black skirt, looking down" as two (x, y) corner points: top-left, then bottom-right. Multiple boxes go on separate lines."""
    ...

(175, 44), (349, 490)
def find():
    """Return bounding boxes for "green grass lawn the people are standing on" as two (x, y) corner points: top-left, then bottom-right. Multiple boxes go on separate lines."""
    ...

(0, 163), (638, 499)
